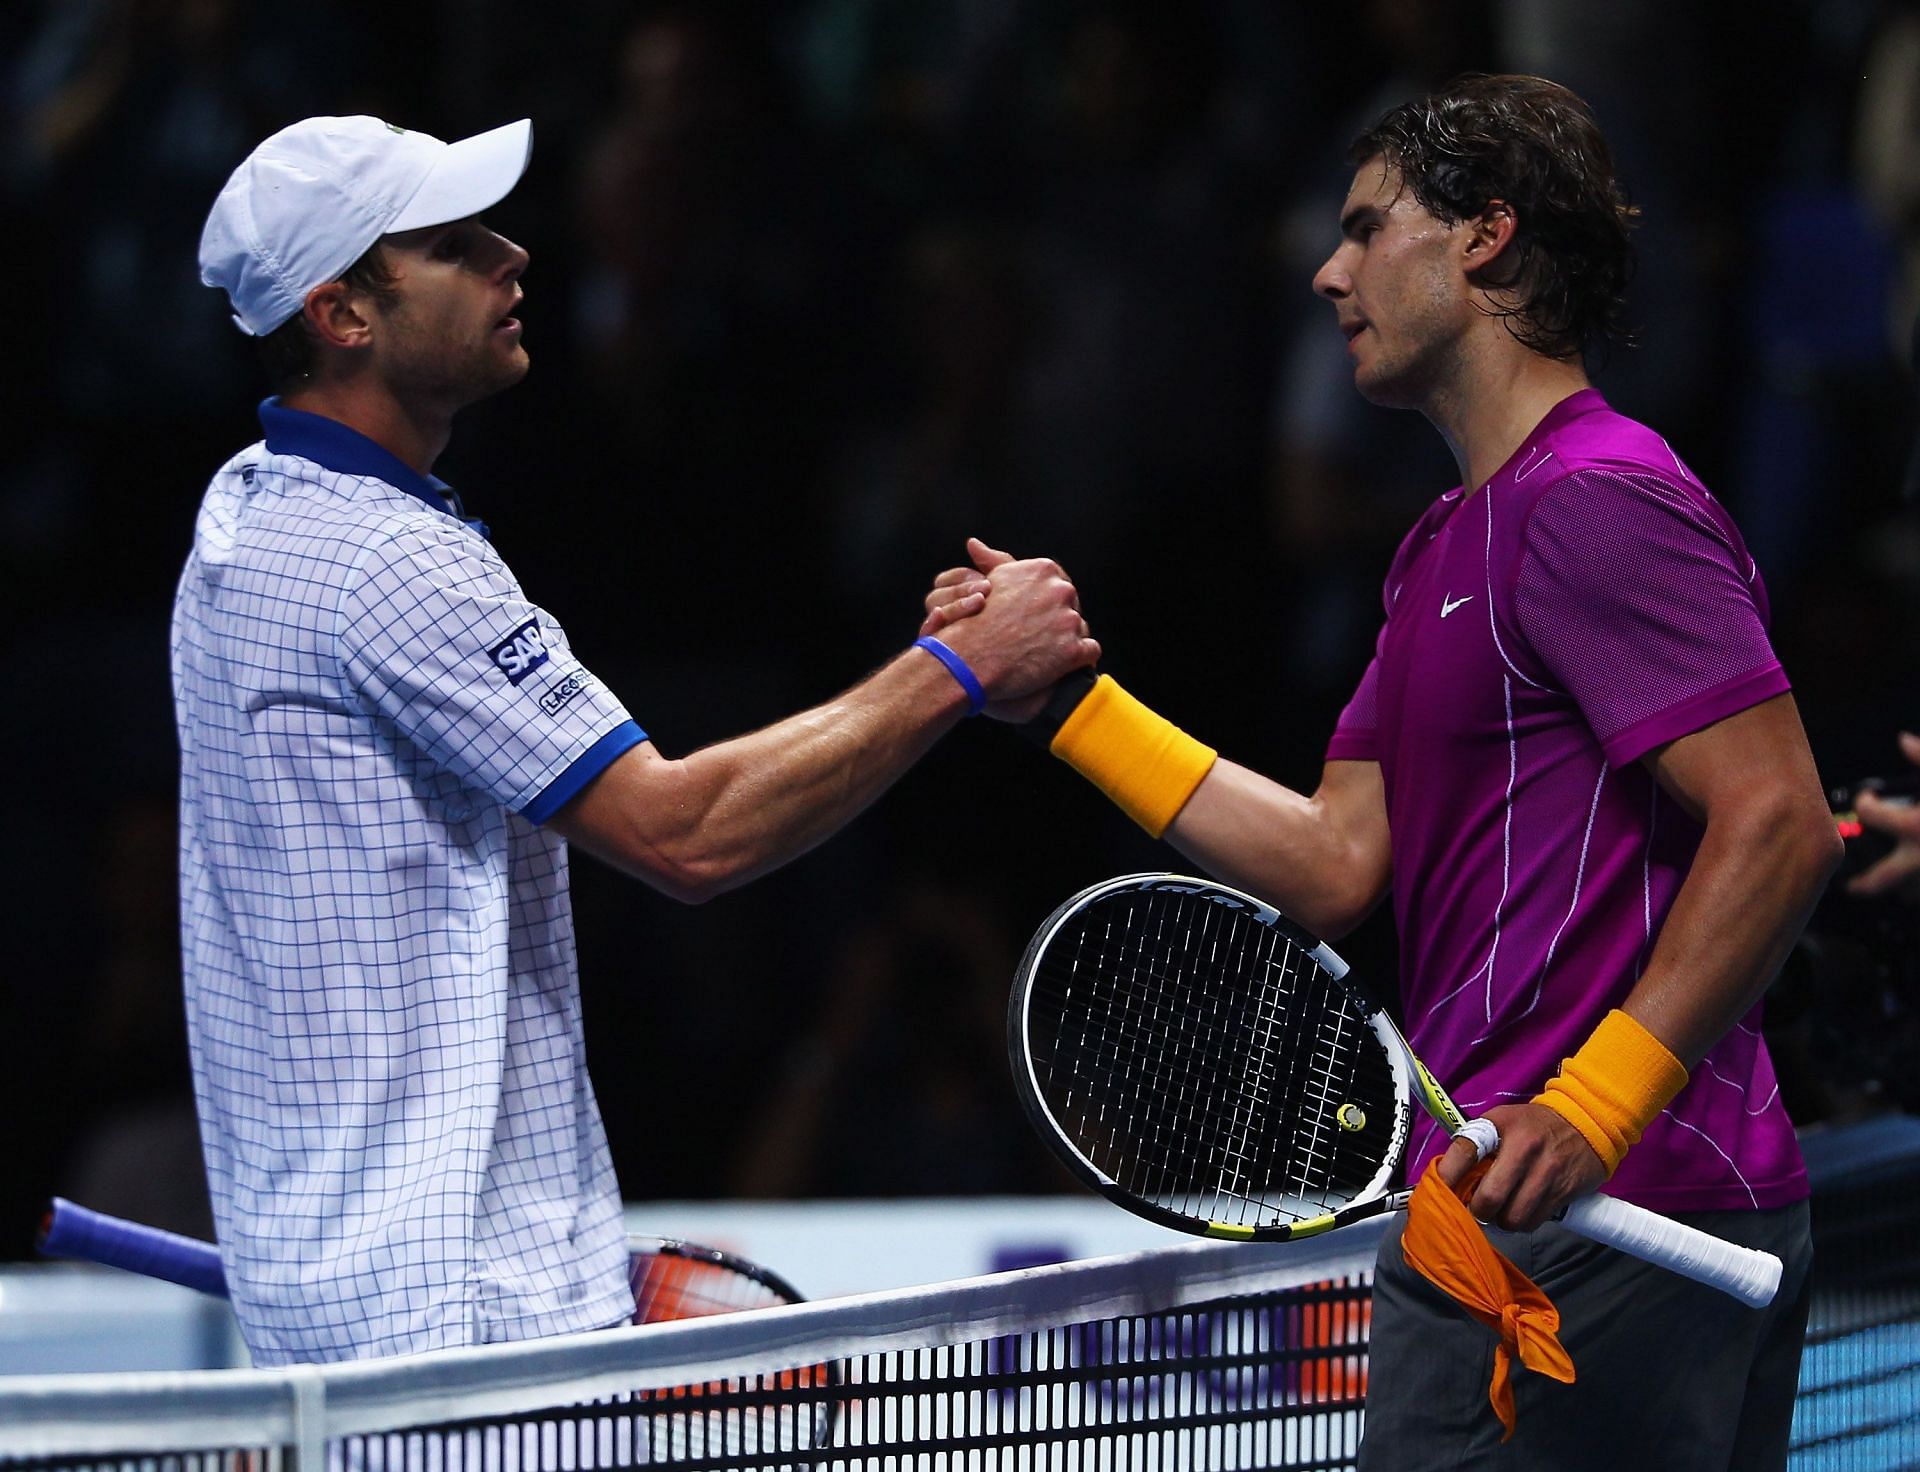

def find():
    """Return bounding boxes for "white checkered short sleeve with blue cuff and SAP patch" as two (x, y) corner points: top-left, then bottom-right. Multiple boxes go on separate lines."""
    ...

(340, 524), (647, 821)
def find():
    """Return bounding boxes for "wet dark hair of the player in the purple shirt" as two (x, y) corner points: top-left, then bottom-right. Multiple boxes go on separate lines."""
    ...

(1346, 73), (1640, 359)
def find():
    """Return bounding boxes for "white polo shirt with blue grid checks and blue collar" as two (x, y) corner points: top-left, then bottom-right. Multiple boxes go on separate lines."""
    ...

(173, 399), (645, 1365)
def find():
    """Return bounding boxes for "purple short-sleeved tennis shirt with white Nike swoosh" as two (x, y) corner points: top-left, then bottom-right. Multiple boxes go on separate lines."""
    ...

(1327, 390), (1807, 1211)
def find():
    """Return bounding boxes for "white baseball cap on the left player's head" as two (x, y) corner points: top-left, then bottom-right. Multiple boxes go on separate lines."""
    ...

(200, 117), (534, 338)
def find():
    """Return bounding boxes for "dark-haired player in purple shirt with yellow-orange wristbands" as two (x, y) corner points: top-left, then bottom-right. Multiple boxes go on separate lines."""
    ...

(927, 77), (1839, 1472)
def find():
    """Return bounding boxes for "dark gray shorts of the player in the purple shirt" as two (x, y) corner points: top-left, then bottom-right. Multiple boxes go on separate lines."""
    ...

(1359, 1201), (1812, 1472)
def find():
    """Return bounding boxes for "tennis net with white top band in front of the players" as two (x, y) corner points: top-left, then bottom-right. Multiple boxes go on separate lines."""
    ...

(0, 1119), (1920, 1472)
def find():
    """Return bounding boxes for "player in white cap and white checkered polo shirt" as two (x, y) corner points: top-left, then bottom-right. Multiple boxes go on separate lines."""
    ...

(187, 117), (1098, 1365)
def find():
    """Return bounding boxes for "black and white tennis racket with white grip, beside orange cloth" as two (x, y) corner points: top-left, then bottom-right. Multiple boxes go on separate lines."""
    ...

(1008, 873), (1780, 1307)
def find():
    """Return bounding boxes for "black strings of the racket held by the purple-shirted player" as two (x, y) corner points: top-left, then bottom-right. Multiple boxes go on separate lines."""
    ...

(1029, 894), (1392, 1224)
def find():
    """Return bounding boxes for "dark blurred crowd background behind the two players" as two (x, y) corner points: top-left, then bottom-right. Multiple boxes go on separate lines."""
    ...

(0, 0), (1920, 1257)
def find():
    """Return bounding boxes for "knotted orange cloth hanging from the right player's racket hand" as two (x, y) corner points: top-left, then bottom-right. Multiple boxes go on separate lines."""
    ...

(1400, 1159), (1572, 1441)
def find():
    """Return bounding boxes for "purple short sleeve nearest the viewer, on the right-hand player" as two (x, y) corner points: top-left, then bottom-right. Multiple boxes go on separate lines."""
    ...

(1513, 470), (1788, 766)
